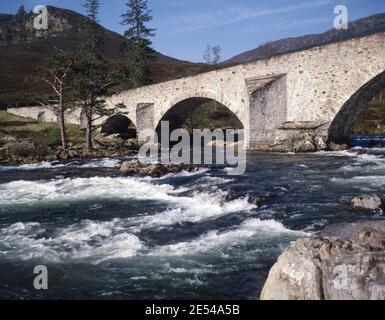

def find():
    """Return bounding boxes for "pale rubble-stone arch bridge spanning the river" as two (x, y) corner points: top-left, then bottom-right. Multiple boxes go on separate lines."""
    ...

(9, 33), (385, 149)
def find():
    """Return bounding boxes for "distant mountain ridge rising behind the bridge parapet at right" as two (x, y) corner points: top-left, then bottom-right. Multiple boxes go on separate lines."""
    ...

(223, 13), (385, 64)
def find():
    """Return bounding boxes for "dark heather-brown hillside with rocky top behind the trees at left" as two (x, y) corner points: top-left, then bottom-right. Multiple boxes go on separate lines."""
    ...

(0, 6), (210, 107)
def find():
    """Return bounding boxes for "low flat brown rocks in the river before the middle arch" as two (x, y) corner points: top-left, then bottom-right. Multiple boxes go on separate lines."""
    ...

(120, 160), (199, 178)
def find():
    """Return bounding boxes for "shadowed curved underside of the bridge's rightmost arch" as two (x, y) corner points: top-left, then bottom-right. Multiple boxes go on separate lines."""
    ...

(329, 71), (385, 144)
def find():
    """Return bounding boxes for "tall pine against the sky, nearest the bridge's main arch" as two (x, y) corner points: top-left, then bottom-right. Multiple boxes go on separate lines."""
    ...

(121, 0), (155, 87)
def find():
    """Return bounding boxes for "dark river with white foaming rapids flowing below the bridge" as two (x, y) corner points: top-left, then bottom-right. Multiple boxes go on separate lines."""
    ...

(0, 149), (385, 299)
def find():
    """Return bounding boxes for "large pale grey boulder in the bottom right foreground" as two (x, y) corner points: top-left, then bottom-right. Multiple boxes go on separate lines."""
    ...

(261, 220), (385, 300)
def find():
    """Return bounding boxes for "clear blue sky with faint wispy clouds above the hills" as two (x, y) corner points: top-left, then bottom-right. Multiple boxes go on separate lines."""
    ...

(0, 0), (385, 62)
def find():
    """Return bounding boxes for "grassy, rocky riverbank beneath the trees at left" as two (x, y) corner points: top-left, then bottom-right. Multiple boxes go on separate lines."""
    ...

(0, 111), (138, 165)
